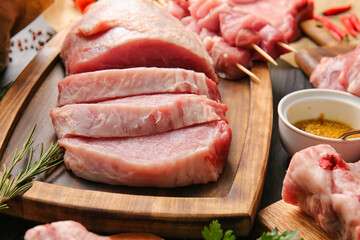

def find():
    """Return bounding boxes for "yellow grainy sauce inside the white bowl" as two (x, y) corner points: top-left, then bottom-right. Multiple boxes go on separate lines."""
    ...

(293, 113), (360, 138)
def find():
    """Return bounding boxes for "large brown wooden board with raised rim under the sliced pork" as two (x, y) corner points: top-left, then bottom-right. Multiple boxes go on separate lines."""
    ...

(0, 26), (273, 238)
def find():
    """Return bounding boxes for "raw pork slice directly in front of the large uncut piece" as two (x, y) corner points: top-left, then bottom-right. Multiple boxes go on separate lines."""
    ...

(58, 67), (220, 106)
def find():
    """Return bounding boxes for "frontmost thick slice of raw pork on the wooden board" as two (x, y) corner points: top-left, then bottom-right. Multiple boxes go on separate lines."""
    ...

(59, 121), (231, 187)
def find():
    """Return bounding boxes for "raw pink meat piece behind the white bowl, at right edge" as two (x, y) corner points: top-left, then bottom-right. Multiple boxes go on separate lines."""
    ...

(310, 45), (360, 96)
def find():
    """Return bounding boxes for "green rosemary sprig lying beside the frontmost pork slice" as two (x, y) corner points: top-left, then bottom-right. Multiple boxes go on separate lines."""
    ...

(0, 124), (64, 210)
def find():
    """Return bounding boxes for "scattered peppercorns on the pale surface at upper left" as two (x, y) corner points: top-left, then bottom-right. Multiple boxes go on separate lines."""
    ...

(9, 28), (55, 62)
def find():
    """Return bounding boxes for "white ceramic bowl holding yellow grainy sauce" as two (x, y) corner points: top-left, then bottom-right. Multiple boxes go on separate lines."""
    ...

(278, 89), (360, 162)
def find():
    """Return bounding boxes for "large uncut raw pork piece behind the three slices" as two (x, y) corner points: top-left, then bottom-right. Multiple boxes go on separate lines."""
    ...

(61, 0), (217, 82)
